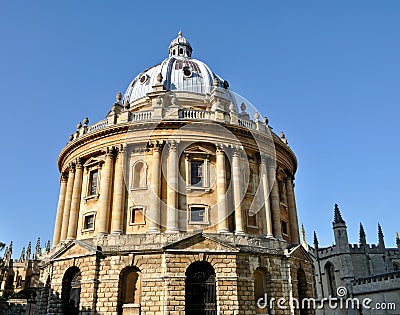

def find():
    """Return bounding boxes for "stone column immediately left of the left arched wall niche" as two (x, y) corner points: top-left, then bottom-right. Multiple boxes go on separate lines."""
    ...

(111, 145), (126, 234)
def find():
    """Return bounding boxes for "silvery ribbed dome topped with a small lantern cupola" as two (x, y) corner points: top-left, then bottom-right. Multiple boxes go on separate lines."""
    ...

(123, 32), (228, 104)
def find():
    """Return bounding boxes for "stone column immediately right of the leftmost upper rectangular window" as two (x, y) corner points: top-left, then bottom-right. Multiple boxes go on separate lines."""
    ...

(95, 147), (114, 235)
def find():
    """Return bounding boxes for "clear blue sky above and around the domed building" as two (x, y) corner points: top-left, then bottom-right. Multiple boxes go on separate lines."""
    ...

(0, 0), (400, 256)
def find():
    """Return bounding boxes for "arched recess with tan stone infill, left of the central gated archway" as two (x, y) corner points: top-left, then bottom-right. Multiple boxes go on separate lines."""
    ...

(118, 267), (142, 314)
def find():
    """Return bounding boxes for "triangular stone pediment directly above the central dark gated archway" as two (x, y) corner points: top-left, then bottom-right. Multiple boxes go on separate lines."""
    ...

(164, 233), (239, 252)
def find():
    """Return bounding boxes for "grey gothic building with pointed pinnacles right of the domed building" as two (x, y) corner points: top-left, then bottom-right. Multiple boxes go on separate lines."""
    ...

(310, 205), (400, 315)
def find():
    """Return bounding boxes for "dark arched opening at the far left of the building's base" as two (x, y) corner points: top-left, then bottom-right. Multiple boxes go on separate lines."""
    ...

(61, 266), (82, 314)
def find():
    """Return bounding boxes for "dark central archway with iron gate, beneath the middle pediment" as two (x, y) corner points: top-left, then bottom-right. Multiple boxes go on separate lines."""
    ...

(185, 261), (217, 315)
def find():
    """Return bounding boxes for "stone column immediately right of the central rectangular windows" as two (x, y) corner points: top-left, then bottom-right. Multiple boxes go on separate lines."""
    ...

(216, 145), (229, 233)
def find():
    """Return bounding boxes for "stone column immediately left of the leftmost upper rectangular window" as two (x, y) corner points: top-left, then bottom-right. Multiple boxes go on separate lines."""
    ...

(67, 159), (83, 239)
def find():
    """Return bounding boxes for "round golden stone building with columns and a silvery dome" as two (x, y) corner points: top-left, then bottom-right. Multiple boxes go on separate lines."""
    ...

(37, 33), (313, 315)
